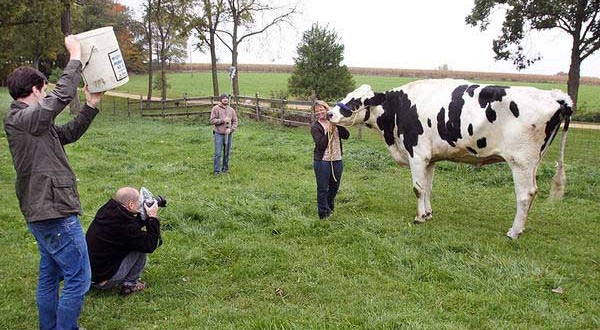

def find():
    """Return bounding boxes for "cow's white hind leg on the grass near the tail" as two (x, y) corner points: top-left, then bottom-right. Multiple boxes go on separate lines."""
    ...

(506, 162), (538, 239)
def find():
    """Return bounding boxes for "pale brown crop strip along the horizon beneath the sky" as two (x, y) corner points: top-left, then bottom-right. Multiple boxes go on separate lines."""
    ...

(169, 63), (600, 85)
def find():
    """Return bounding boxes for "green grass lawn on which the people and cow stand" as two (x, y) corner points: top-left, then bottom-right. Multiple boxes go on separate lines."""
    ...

(0, 81), (600, 329)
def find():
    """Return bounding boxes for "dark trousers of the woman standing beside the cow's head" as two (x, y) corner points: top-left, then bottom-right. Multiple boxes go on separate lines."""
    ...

(313, 160), (344, 219)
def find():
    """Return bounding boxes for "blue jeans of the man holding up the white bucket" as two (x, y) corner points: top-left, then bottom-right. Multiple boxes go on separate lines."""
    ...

(27, 215), (92, 330)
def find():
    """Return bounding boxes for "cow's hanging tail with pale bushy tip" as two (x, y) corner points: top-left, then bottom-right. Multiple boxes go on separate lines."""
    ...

(550, 91), (573, 201)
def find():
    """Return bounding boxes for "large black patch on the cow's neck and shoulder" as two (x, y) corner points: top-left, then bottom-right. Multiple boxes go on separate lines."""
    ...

(377, 91), (424, 157)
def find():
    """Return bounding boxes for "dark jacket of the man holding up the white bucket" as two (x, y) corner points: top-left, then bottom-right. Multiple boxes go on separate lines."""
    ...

(4, 60), (98, 222)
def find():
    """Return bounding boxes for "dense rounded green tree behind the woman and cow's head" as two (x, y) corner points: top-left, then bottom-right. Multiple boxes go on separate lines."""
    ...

(288, 24), (354, 101)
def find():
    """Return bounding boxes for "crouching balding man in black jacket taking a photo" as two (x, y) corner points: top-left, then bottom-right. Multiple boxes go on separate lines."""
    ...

(85, 187), (166, 295)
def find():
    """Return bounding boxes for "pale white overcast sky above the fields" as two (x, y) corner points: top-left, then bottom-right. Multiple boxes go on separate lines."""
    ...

(117, 0), (600, 77)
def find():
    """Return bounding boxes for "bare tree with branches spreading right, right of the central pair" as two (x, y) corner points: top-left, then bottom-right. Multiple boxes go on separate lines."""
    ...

(217, 0), (297, 95)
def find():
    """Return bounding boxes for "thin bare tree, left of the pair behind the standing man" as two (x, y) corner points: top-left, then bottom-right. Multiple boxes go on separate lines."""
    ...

(193, 0), (225, 96)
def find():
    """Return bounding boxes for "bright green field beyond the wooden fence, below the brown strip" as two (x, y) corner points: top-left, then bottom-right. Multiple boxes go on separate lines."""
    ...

(115, 71), (600, 116)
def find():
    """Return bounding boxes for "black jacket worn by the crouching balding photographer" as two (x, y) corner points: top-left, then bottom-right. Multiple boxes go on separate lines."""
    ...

(85, 199), (162, 283)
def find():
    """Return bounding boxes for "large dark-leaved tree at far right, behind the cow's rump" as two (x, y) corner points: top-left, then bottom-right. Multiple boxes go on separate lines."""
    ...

(466, 0), (600, 111)
